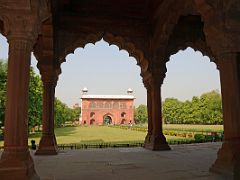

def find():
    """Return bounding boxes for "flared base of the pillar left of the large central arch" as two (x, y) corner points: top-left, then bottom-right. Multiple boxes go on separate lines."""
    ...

(35, 135), (58, 155)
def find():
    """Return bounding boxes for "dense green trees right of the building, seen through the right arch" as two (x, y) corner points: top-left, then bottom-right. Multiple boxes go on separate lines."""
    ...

(162, 90), (223, 124)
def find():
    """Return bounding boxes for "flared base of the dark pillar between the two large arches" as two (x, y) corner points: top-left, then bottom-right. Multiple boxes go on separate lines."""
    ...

(144, 134), (171, 151)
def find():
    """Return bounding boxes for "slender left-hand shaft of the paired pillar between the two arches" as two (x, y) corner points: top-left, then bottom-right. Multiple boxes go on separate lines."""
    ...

(144, 82), (153, 148)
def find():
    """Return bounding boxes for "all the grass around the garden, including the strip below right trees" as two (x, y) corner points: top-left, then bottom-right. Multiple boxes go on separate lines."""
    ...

(0, 124), (223, 146)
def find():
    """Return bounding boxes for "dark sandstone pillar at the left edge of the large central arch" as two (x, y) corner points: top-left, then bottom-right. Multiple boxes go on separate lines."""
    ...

(35, 67), (58, 155)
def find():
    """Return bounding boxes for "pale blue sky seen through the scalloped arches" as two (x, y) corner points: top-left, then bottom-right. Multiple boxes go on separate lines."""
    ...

(0, 35), (220, 107)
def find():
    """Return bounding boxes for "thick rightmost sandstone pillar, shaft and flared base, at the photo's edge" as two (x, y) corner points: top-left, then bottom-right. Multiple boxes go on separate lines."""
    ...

(210, 53), (240, 179)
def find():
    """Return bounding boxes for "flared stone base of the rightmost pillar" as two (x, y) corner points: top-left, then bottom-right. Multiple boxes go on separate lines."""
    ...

(210, 139), (240, 180)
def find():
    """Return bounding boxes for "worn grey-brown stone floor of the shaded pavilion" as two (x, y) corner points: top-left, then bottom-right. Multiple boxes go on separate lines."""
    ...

(25, 143), (228, 180)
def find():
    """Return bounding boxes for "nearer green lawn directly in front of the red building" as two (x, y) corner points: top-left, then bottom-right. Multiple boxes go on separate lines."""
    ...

(0, 126), (189, 146)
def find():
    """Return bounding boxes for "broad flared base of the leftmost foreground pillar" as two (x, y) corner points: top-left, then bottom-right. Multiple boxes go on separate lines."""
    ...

(0, 150), (40, 180)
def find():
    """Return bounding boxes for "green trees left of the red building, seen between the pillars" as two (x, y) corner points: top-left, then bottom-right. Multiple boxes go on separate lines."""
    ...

(0, 60), (80, 130)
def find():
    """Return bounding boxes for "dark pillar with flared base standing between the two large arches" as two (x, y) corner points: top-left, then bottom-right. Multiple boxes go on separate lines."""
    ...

(145, 73), (170, 150)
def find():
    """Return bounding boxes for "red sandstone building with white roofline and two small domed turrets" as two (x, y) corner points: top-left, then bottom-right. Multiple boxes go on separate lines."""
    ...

(80, 88), (134, 125)
